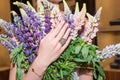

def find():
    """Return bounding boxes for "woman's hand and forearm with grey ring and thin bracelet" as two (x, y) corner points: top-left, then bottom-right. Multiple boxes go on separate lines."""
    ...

(24, 21), (71, 80)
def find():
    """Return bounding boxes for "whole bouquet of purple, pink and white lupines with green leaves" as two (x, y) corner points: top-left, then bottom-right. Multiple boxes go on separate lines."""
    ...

(0, 0), (120, 80)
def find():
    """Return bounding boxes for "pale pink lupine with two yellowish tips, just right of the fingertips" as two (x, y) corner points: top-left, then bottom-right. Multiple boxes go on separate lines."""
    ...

(70, 3), (86, 40)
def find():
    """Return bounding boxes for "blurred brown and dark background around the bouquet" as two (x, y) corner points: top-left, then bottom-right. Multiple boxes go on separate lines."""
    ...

(0, 0), (120, 80)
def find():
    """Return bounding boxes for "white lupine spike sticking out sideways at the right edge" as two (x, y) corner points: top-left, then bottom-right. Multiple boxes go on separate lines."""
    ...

(96, 43), (120, 59)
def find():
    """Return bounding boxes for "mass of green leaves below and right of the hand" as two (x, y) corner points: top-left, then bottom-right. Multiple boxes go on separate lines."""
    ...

(43, 37), (105, 80)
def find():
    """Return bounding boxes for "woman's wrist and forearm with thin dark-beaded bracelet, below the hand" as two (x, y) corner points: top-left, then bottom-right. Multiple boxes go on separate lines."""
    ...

(23, 56), (48, 80)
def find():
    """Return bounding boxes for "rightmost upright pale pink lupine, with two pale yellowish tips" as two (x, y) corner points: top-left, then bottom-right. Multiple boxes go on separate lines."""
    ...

(80, 8), (102, 44)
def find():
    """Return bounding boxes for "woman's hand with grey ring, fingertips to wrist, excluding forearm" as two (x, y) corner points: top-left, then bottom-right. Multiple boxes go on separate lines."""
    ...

(38, 21), (71, 66)
